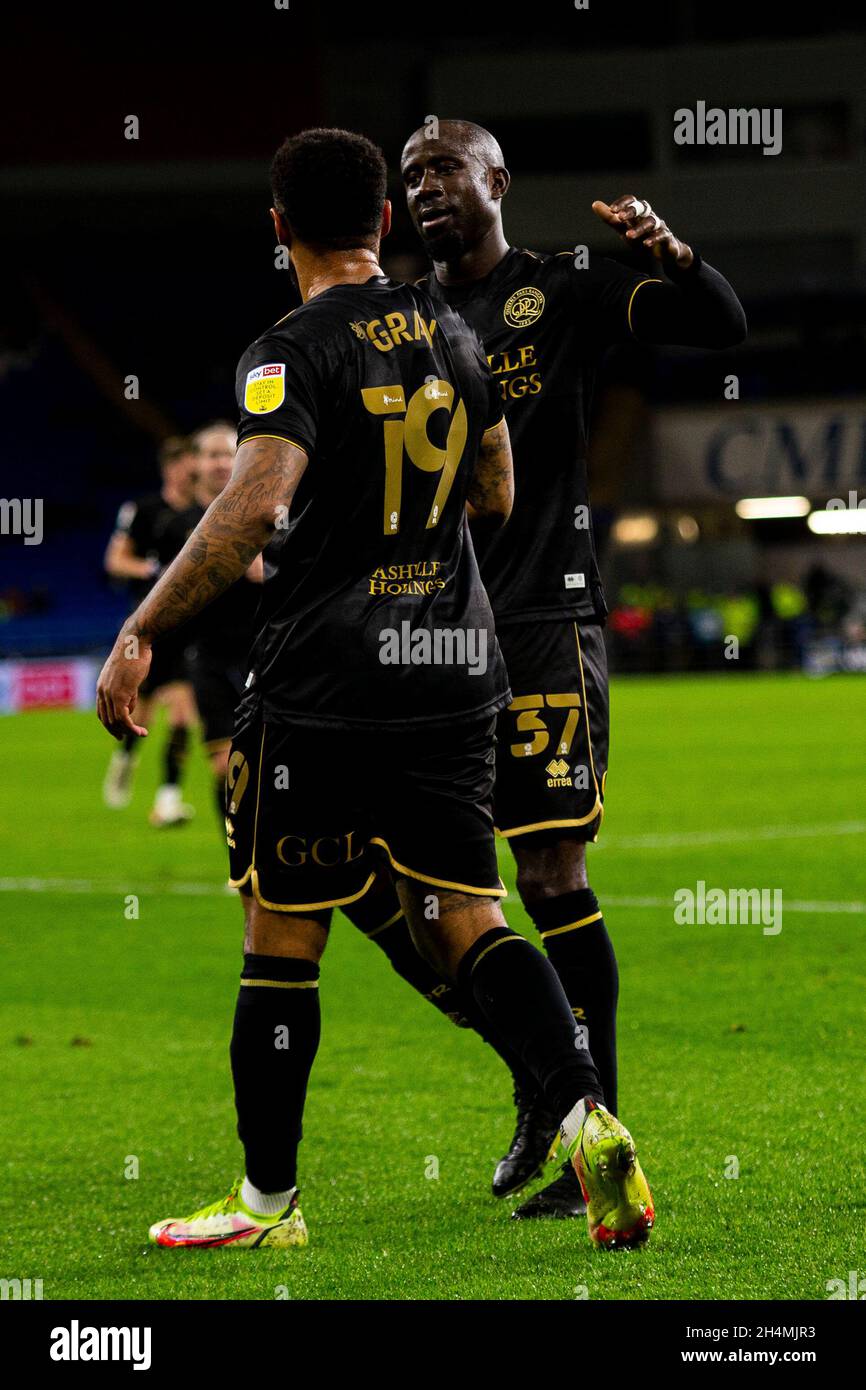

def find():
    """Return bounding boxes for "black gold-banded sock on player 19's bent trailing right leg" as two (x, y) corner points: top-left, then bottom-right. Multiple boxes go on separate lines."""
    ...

(457, 927), (605, 1119)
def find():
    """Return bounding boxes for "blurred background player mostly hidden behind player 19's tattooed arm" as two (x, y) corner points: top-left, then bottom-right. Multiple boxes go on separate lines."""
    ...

(178, 420), (264, 830)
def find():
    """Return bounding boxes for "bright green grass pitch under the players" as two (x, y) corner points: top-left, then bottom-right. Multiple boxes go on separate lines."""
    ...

(0, 674), (866, 1300)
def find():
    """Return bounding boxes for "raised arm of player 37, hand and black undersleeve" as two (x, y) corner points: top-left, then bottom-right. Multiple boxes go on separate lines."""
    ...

(592, 193), (746, 348)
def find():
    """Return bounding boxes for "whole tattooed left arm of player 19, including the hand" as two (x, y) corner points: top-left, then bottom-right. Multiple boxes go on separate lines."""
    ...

(96, 438), (307, 738)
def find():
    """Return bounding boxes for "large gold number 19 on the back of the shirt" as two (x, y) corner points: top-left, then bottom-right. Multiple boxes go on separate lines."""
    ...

(361, 381), (468, 535)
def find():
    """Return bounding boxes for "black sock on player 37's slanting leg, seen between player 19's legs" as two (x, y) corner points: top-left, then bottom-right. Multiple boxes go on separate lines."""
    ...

(343, 887), (538, 1093)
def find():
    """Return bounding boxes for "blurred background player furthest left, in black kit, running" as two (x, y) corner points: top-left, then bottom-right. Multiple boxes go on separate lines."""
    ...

(103, 436), (200, 826)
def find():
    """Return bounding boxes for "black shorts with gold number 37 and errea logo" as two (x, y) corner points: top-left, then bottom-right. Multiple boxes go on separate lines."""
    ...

(493, 620), (609, 840)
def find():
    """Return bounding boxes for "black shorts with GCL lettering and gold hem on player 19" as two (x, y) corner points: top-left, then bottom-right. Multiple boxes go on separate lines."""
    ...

(225, 716), (505, 913)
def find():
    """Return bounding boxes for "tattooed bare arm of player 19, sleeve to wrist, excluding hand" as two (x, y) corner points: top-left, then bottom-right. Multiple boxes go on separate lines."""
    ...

(122, 439), (307, 641)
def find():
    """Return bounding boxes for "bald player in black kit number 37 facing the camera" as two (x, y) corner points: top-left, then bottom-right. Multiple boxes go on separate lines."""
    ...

(337, 121), (745, 1218)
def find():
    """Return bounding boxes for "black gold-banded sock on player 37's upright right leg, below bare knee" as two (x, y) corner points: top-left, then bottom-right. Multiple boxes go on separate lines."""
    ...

(528, 888), (620, 1115)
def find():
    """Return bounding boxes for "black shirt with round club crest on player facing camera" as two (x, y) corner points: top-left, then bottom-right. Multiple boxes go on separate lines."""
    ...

(421, 247), (661, 626)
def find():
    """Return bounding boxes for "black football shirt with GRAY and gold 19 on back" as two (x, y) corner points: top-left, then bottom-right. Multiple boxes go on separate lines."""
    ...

(236, 268), (510, 728)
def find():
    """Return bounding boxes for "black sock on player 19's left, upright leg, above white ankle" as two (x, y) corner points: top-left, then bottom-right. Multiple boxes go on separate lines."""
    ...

(231, 955), (321, 1193)
